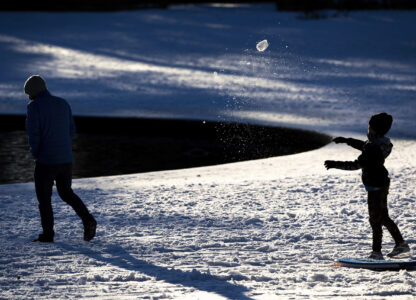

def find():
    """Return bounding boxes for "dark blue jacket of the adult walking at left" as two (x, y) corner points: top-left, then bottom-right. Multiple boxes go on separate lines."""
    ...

(26, 91), (75, 164)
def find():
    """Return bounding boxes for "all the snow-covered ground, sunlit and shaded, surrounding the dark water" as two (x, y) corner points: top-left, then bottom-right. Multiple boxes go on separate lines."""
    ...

(0, 5), (416, 299)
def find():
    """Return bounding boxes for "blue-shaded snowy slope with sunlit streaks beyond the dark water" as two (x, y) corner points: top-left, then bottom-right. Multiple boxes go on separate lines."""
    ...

(0, 5), (416, 136)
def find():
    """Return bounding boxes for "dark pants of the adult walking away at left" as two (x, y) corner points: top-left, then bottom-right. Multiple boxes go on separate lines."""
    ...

(35, 162), (91, 237)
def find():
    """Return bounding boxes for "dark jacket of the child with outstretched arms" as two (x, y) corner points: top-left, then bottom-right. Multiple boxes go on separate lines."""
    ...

(338, 135), (393, 187)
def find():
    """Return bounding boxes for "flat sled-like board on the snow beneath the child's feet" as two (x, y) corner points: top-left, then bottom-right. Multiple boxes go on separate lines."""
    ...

(335, 258), (416, 271)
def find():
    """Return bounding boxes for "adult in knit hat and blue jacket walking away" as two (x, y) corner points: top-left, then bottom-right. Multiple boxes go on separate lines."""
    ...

(24, 75), (97, 242)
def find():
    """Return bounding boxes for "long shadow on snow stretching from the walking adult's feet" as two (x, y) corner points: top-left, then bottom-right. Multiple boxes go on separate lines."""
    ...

(55, 242), (252, 300)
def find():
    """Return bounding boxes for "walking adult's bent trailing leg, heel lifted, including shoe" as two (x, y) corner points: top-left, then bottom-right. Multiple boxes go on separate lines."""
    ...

(56, 164), (97, 241)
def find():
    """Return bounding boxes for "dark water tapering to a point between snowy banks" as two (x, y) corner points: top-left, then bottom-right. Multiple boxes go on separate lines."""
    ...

(0, 116), (330, 184)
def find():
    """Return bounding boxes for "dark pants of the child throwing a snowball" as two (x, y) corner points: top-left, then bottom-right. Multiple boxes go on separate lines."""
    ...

(368, 187), (403, 252)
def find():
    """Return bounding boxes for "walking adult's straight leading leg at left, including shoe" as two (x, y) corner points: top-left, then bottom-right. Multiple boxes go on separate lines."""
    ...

(35, 163), (54, 242)
